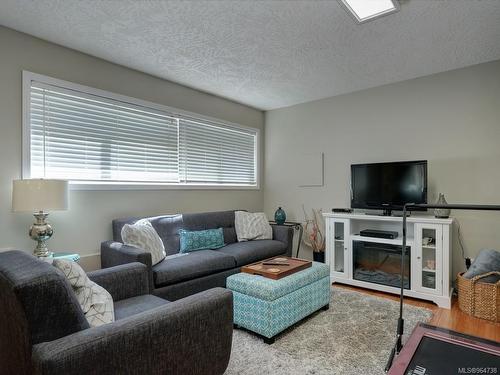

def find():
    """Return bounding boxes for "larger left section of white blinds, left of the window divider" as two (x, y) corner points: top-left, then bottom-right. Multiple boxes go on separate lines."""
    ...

(30, 83), (179, 182)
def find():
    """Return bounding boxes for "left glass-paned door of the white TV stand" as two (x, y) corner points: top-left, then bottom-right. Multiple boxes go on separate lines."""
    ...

(329, 219), (349, 277)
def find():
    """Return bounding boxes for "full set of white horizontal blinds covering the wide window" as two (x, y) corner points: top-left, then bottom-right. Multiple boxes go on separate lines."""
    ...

(28, 76), (257, 185)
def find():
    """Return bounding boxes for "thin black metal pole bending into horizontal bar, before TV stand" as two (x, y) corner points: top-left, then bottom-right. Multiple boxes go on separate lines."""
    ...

(385, 203), (500, 372)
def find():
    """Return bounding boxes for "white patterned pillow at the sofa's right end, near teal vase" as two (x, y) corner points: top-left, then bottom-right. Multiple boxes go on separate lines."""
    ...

(234, 211), (273, 242)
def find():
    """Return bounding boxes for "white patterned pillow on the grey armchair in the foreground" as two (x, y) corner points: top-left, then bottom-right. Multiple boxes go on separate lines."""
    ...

(52, 259), (115, 327)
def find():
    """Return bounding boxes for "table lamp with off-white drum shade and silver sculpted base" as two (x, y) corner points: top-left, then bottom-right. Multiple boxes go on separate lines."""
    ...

(12, 179), (68, 257)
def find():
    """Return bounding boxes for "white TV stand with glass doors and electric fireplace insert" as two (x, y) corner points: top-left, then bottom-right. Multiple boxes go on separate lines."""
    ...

(323, 213), (453, 309)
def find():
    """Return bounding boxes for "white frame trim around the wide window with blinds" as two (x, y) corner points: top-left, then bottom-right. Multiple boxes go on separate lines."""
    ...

(22, 70), (262, 190)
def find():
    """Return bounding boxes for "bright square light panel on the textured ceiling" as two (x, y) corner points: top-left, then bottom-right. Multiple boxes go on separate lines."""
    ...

(339, 0), (399, 23)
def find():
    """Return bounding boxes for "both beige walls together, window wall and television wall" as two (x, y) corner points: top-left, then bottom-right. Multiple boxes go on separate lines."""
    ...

(0, 27), (500, 271)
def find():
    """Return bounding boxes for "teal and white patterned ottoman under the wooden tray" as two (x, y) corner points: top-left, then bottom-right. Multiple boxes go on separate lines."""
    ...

(226, 262), (330, 344)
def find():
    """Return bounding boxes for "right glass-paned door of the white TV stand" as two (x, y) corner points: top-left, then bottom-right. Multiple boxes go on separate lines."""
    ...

(414, 224), (442, 294)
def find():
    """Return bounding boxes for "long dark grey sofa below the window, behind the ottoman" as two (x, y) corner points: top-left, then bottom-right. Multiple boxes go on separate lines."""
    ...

(101, 211), (293, 301)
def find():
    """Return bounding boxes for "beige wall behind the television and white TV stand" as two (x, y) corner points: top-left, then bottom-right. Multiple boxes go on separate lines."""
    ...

(264, 61), (500, 272)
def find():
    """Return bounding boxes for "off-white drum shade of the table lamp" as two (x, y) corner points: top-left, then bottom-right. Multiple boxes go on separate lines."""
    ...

(12, 179), (68, 212)
